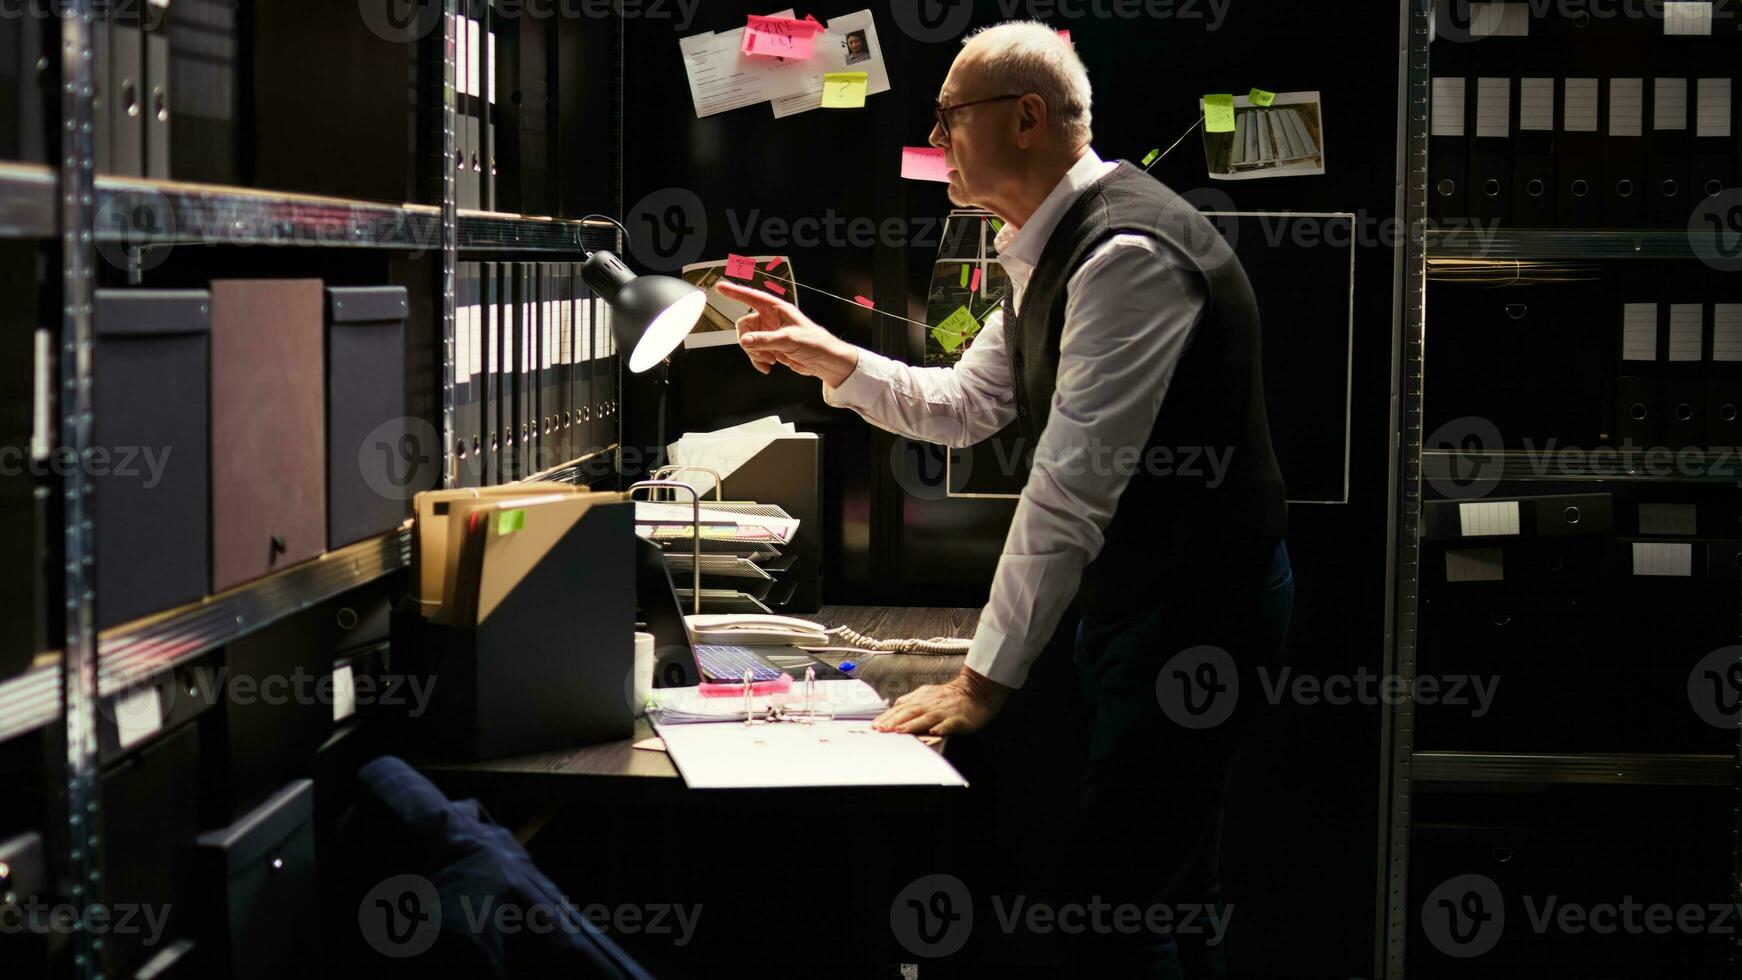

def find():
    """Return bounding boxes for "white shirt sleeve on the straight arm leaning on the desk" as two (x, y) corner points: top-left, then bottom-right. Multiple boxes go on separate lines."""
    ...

(967, 235), (1205, 688)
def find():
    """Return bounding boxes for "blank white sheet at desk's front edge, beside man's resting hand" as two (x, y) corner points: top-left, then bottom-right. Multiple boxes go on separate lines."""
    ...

(657, 721), (969, 789)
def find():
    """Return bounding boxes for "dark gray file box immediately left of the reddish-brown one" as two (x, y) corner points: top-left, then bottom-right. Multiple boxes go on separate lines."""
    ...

(91, 289), (209, 628)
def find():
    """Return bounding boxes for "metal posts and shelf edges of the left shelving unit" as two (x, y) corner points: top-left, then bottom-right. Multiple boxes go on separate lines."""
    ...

(0, 0), (622, 977)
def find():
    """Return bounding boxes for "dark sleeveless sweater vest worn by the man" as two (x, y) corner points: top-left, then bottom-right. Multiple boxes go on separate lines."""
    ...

(1003, 164), (1287, 611)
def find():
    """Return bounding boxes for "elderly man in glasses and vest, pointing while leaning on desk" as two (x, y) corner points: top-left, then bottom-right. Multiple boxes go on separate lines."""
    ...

(721, 23), (1294, 977)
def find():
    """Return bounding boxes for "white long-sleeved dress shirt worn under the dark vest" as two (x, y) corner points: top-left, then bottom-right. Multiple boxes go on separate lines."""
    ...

(822, 150), (1205, 688)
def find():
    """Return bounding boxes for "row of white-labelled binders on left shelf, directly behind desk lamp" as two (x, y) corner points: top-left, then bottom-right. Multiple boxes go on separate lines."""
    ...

(453, 261), (618, 487)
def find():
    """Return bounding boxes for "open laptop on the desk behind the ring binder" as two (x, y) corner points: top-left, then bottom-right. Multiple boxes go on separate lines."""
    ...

(636, 536), (847, 688)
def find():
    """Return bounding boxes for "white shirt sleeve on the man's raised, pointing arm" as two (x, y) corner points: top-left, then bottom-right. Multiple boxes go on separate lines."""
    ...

(822, 312), (1016, 447)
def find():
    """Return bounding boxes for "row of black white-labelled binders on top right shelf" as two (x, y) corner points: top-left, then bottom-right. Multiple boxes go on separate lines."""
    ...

(1428, 3), (1742, 228)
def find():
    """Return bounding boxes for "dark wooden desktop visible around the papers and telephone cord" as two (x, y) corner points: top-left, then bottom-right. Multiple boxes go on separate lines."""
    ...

(423, 606), (981, 783)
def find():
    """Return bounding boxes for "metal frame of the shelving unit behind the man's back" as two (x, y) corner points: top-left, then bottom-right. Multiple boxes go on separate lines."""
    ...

(1374, 0), (1742, 980)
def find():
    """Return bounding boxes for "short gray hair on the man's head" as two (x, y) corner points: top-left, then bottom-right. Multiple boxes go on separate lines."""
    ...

(962, 21), (1094, 143)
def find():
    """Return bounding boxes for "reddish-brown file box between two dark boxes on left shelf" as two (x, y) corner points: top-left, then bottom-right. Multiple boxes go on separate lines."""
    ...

(211, 279), (326, 592)
